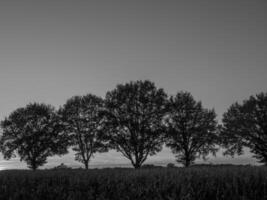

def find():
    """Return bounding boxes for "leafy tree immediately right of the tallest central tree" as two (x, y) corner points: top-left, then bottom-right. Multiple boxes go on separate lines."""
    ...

(164, 92), (217, 167)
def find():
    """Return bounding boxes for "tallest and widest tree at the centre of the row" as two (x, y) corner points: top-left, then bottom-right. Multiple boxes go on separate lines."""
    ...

(105, 80), (167, 168)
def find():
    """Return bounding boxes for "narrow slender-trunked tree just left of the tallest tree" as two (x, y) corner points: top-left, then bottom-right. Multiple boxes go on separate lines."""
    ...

(59, 94), (108, 169)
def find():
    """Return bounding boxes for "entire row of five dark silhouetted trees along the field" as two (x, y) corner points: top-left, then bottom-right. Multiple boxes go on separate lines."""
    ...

(0, 80), (267, 170)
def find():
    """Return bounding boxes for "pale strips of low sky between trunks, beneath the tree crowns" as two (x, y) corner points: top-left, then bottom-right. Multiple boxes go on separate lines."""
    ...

(0, 147), (260, 170)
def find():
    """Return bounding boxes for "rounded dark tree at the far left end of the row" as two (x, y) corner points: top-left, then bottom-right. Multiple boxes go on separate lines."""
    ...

(0, 103), (67, 170)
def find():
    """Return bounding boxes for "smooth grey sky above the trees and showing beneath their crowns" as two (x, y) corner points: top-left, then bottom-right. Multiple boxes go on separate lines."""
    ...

(0, 0), (267, 169)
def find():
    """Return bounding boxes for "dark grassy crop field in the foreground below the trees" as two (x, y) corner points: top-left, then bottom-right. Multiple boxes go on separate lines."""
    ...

(0, 166), (267, 200)
